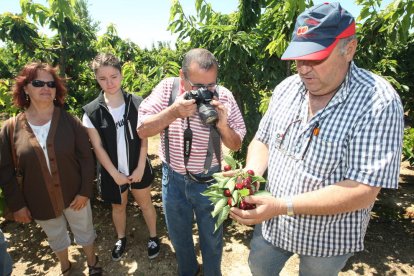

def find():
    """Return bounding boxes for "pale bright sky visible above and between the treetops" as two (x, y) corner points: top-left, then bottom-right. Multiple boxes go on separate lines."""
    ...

(0, 0), (390, 48)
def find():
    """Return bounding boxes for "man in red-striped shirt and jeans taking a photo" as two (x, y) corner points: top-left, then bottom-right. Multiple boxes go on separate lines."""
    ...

(138, 49), (246, 276)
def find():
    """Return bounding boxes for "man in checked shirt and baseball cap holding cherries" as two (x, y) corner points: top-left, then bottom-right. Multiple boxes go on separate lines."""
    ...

(231, 3), (404, 275)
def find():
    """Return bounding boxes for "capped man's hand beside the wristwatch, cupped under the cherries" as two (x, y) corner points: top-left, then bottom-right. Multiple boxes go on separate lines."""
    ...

(230, 196), (284, 225)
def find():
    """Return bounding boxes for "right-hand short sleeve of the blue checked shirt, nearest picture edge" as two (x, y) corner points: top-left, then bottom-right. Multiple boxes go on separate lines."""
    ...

(345, 99), (404, 188)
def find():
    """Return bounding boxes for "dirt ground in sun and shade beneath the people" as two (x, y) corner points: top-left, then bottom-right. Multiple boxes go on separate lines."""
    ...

(0, 135), (414, 276)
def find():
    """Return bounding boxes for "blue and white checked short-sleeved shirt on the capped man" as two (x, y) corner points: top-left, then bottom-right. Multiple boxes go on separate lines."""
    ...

(256, 63), (404, 257)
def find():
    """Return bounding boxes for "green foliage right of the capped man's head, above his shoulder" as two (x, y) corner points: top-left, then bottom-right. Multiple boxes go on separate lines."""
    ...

(355, 0), (414, 123)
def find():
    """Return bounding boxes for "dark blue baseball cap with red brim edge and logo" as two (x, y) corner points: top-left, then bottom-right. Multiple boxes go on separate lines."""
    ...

(282, 2), (355, 60)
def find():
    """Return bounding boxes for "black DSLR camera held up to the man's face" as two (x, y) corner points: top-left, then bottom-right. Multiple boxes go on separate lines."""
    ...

(184, 87), (218, 125)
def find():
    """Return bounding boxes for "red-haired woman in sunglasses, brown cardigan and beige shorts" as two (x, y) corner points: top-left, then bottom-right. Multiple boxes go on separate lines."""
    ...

(0, 63), (102, 275)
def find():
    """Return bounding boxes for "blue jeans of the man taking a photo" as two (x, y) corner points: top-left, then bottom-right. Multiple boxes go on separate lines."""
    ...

(162, 163), (223, 276)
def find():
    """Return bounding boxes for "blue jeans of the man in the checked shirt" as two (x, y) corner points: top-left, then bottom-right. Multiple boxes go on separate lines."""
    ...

(249, 224), (353, 276)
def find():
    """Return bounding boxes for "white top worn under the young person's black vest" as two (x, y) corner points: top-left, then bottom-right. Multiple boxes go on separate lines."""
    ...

(82, 103), (129, 176)
